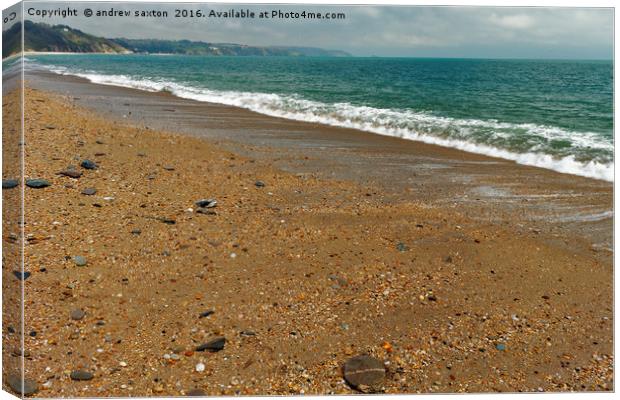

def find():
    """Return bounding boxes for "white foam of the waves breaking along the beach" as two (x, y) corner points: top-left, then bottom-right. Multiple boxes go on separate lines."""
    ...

(44, 67), (614, 182)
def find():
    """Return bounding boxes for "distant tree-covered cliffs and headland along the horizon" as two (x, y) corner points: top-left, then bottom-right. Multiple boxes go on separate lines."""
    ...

(2, 21), (350, 58)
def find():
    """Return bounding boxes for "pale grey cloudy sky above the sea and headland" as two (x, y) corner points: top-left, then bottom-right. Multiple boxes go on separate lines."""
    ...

(9, 2), (614, 59)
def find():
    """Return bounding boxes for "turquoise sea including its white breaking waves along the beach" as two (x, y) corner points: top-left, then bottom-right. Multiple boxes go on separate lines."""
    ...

(20, 54), (613, 181)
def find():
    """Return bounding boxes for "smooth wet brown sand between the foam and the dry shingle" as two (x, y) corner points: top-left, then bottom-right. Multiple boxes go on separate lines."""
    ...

(26, 72), (613, 251)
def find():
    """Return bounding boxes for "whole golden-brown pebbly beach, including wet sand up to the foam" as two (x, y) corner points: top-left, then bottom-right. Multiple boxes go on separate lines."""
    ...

(3, 73), (613, 397)
